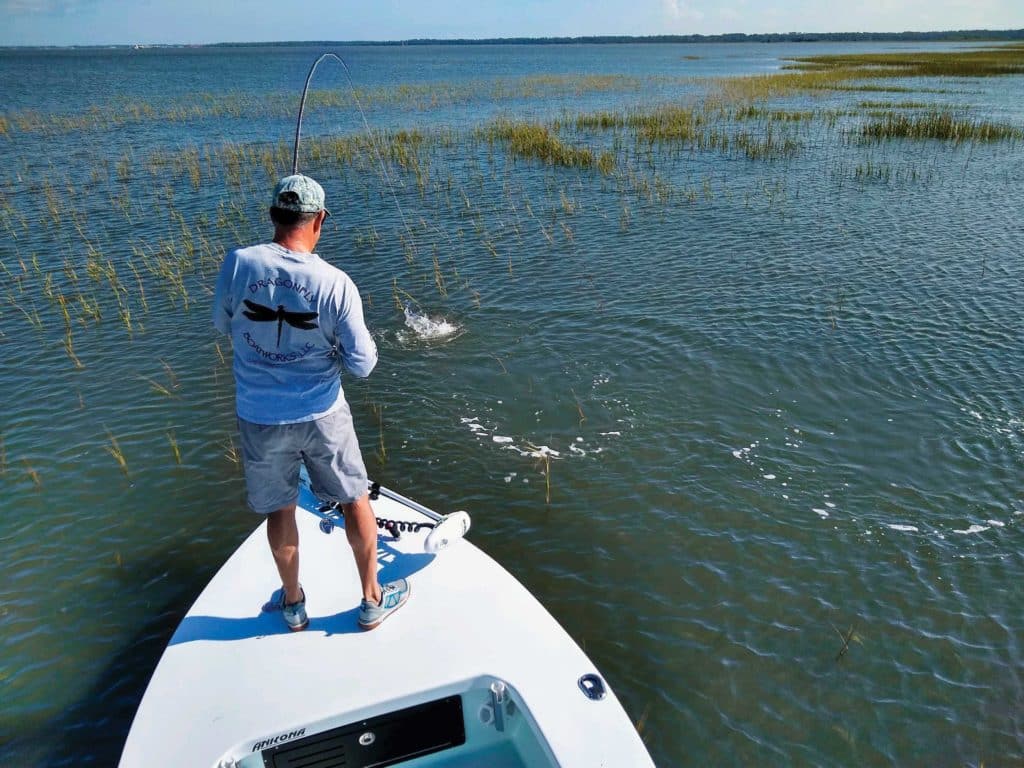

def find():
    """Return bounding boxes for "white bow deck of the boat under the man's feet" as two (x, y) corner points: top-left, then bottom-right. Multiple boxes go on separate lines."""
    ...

(121, 483), (652, 768)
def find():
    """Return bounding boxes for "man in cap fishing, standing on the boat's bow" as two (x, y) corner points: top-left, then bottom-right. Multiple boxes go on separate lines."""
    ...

(213, 175), (410, 632)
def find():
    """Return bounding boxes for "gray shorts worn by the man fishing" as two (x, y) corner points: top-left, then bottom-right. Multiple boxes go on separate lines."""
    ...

(239, 402), (368, 515)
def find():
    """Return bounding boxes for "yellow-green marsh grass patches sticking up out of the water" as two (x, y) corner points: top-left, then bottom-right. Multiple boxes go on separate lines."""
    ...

(0, 49), (1024, 493)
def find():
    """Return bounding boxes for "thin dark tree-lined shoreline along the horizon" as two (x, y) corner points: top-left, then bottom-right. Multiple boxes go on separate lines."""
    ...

(8, 29), (1024, 50)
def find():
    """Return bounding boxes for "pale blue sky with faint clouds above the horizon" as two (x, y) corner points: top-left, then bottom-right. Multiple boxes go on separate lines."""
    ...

(0, 0), (1024, 45)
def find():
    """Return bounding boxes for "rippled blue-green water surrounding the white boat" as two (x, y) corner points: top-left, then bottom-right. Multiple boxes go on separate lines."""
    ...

(0, 45), (1024, 766)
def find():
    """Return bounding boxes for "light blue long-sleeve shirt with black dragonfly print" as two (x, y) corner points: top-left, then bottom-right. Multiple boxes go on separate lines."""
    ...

(213, 243), (377, 424)
